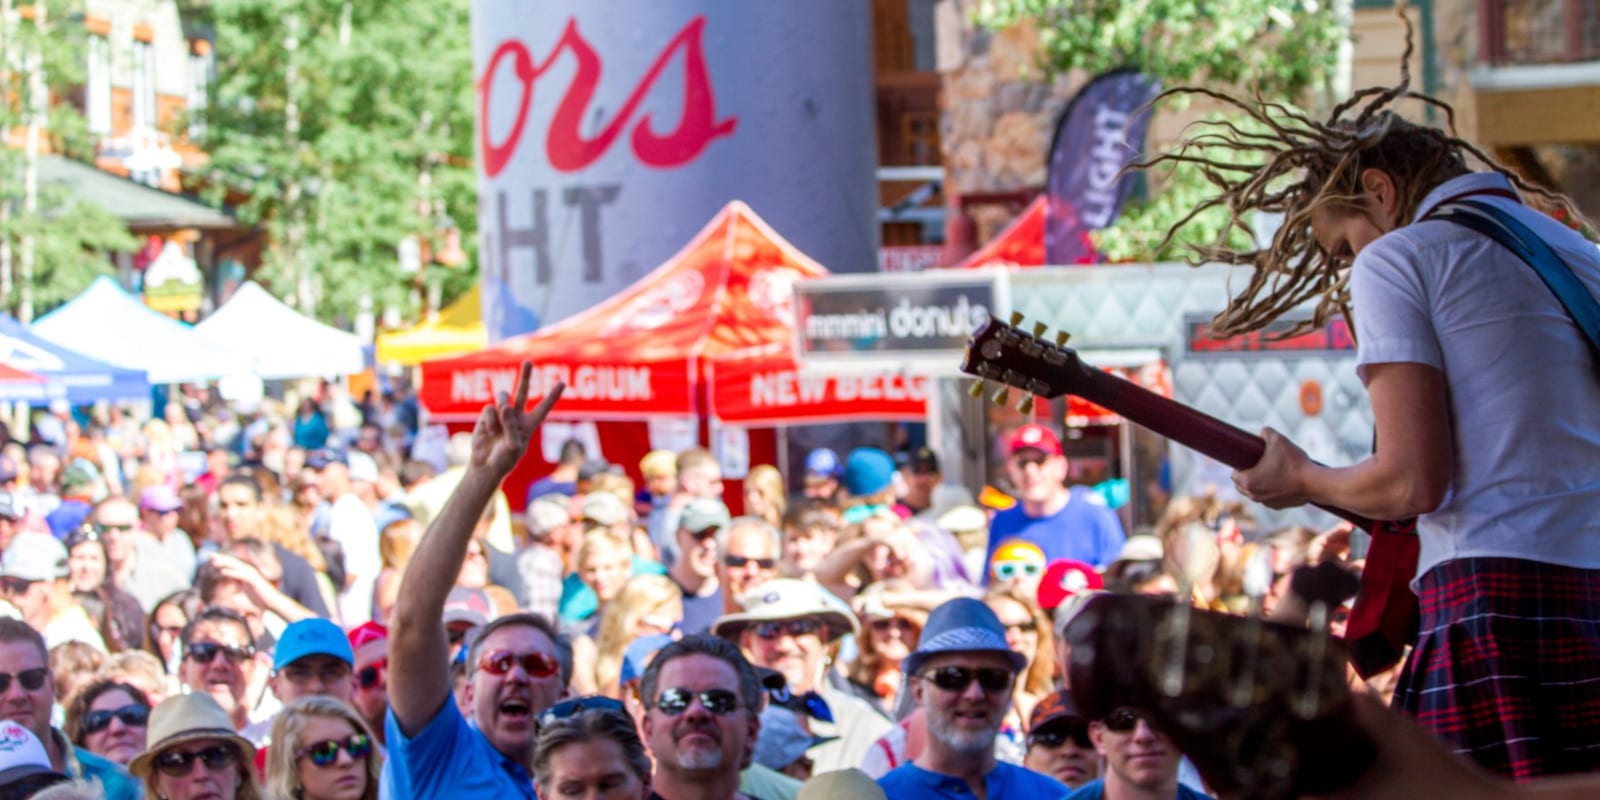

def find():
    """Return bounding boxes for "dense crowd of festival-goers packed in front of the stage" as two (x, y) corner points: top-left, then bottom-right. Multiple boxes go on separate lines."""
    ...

(0, 347), (1561, 800)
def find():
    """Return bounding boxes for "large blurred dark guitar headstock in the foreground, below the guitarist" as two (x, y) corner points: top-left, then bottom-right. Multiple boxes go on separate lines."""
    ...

(1066, 594), (1376, 800)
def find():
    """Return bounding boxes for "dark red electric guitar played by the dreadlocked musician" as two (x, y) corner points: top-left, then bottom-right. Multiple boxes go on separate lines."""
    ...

(962, 314), (1418, 677)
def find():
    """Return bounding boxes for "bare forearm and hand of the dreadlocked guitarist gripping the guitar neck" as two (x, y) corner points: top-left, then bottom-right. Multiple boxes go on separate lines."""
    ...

(1234, 363), (1456, 520)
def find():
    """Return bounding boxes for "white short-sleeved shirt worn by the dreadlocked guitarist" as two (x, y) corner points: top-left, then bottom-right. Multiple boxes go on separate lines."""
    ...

(1350, 173), (1600, 576)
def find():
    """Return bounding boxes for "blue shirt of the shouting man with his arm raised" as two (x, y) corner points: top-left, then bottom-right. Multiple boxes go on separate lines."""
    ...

(384, 698), (534, 800)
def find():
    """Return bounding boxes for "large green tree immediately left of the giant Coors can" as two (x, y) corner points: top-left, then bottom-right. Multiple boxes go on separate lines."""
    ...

(205, 0), (477, 318)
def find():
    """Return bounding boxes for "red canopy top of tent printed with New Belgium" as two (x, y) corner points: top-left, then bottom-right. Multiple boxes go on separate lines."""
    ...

(421, 202), (926, 426)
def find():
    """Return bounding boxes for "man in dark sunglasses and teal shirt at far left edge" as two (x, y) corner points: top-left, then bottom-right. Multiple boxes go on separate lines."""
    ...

(0, 618), (144, 800)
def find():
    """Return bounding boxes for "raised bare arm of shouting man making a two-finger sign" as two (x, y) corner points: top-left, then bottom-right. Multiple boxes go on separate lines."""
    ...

(389, 363), (565, 736)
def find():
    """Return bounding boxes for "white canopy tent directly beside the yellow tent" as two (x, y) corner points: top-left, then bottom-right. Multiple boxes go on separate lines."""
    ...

(195, 282), (366, 381)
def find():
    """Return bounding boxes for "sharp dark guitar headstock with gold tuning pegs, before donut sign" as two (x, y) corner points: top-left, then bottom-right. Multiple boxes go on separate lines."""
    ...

(962, 314), (1094, 414)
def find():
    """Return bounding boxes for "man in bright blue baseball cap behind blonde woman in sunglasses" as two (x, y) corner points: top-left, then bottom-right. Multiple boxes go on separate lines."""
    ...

(240, 616), (355, 747)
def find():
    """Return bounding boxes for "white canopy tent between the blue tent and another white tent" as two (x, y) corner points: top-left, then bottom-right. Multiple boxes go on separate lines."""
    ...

(32, 277), (250, 384)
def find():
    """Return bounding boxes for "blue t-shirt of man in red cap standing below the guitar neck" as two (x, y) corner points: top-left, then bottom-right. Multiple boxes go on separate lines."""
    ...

(984, 486), (1128, 581)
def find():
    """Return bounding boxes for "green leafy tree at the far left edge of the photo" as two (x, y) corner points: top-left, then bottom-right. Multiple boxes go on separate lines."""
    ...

(0, 0), (138, 320)
